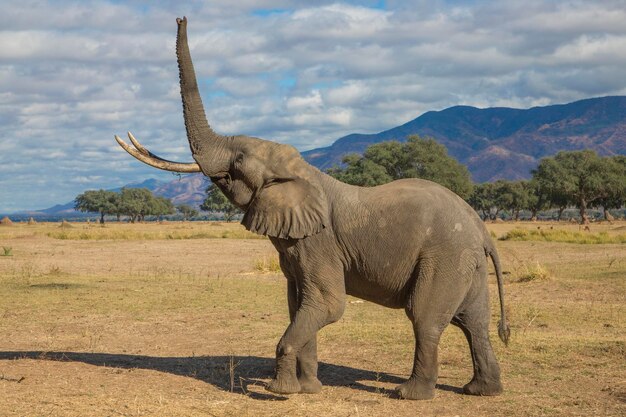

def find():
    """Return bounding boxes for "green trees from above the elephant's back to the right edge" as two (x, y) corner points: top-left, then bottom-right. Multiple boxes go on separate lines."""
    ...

(327, 136), (626, 223)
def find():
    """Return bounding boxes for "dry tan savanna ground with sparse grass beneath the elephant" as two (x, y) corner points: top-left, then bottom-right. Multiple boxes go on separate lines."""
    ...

(0, 222), (626, 416)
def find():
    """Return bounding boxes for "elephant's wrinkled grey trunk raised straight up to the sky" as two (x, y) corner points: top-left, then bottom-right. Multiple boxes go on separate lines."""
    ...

(176, 18), (230, 176)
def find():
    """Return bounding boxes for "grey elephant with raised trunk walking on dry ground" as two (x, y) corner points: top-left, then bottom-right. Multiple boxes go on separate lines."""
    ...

(115, 17), (510, 399)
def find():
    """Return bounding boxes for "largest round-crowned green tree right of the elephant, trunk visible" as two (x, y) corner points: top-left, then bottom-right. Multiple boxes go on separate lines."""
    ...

(533, 150), (610, 223)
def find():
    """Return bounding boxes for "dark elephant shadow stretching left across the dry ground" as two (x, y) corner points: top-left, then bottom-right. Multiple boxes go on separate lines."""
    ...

(0, 351), (462, 400)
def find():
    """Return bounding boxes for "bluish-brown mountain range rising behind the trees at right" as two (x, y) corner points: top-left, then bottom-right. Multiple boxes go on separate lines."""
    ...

(302, 96), (626, 182)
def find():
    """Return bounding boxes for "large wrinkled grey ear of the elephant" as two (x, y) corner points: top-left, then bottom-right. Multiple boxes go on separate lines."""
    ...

(241, 145), (328, 239)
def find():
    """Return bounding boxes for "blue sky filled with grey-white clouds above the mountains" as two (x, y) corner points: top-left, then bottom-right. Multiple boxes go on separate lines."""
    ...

(0, 0), (626, 213)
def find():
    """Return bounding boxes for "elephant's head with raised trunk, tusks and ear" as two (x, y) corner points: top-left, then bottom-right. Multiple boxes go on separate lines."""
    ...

(115, 18), (328, 239)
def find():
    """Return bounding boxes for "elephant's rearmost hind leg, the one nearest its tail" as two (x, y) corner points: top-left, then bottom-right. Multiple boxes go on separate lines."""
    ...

(452, 270), (502, 395)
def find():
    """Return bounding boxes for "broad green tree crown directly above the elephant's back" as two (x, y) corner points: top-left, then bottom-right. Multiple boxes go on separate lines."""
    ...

(328, 135), (473, 199)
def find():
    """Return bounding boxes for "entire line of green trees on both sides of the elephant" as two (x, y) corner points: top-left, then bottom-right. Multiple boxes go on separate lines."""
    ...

(75, 135), (626, 223)
